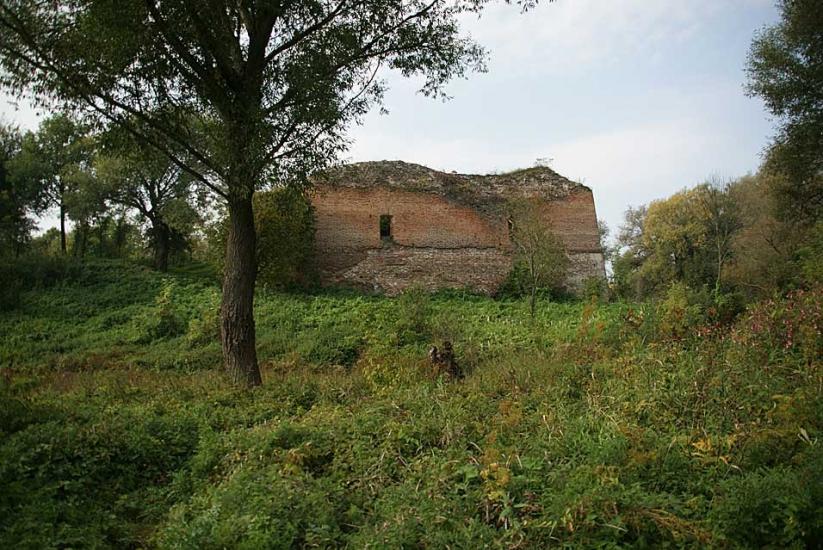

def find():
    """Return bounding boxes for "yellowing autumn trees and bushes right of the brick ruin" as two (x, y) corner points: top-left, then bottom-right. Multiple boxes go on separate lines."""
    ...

(607, 169), (823, 305)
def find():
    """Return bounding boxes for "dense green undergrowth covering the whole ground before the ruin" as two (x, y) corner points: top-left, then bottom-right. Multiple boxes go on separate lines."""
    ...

(0, 262), (823, 548)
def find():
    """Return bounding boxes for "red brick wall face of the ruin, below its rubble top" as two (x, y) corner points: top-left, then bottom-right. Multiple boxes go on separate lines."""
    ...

(312, 178), (605, 294)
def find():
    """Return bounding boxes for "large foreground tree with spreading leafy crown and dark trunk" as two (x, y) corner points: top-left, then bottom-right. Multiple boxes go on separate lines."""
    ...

(0, 0), (532, 386)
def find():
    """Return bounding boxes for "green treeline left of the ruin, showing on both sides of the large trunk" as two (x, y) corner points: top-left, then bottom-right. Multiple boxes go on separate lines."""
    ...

(0, 114), (314, 292)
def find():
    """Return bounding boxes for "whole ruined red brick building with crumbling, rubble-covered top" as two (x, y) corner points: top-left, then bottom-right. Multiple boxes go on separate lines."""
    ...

(312, 161), (605, 294)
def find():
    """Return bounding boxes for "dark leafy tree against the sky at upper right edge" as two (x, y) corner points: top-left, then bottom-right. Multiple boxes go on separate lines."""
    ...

(747, 0), (823, 226)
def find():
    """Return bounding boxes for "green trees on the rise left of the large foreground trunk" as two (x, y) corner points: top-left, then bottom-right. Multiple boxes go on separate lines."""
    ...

(0, 114), (204, 270)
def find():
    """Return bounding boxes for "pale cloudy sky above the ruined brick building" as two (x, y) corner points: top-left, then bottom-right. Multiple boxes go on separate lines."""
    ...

(0, 0), (777, 235)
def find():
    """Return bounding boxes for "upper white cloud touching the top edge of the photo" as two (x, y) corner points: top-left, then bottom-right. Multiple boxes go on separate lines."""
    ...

(464, 0), (732, 76)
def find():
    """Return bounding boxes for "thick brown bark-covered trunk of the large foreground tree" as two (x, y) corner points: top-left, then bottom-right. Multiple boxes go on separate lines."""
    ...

(220, 191), (262, 388)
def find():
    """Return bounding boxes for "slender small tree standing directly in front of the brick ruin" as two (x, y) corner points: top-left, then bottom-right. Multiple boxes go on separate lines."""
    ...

(509, 201), (569, 318)
